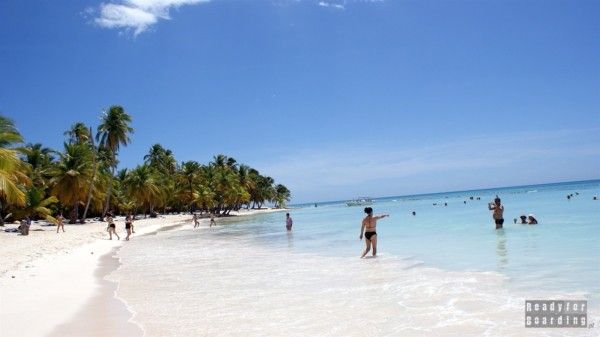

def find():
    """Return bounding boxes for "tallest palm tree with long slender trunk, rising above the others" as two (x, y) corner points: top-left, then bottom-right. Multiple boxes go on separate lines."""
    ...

(96, 105), (133, 217)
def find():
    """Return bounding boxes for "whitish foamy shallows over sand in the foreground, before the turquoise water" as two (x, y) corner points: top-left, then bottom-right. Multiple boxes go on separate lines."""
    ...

(110, 228), (598, 337)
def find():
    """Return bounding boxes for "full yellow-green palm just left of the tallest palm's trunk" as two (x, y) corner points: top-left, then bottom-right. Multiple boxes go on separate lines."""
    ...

(51, 143), (92, 223)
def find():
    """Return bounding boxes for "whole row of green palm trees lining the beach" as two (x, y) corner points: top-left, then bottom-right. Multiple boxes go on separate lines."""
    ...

(0, 105), (291, 225)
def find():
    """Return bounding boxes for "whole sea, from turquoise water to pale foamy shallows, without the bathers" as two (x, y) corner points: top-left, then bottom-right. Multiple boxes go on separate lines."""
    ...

(109, 181), (600, 336)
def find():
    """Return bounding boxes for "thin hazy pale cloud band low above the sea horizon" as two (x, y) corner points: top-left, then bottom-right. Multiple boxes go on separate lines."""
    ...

(257, 129), (600, 200)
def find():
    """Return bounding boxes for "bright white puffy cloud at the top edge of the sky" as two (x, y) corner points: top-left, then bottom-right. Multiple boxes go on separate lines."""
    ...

(94, 0), (210, 35)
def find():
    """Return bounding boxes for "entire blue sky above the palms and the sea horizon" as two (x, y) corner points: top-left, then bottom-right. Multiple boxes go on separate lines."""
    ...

(0, 0), (600, 202)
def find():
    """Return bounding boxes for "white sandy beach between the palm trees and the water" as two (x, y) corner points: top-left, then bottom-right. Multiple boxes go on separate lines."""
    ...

(0, 210), (284, 337)
